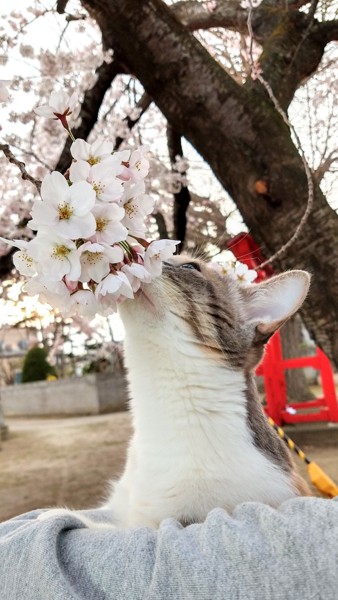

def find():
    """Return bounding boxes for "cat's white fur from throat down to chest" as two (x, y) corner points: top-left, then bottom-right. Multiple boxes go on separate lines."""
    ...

(106, 315), (295, 526)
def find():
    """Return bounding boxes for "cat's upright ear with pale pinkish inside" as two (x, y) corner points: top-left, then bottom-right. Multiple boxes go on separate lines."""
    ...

(246, 271), (310, 336)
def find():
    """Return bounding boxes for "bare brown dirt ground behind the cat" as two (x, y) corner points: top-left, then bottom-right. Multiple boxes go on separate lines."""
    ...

(0, 413), (338, 521)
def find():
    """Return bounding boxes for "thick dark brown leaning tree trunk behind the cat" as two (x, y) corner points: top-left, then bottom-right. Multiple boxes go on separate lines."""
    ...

(82, 0), (338, 365)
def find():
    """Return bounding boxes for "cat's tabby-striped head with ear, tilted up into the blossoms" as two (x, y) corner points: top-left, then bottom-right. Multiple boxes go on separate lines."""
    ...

(121, 255), (310, 369)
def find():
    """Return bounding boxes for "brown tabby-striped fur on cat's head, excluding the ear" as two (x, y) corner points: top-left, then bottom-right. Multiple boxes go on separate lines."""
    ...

(163, 256), (252, 367)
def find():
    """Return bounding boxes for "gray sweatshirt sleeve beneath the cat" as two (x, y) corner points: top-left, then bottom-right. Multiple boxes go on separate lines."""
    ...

(0, 498), (338, 600)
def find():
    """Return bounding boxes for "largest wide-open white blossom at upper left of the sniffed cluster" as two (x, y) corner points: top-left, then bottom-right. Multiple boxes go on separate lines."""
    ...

(28, 171), (96, 239)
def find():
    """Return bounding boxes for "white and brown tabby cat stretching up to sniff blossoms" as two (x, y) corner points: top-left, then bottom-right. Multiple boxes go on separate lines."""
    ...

(40, 255), (310, 528)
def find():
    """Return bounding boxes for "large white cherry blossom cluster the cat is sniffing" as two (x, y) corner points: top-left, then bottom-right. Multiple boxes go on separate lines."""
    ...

(1, 91), (178, 318)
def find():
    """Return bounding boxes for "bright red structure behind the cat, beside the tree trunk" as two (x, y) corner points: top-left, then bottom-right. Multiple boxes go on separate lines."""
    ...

(228, 233), (338, 425)
